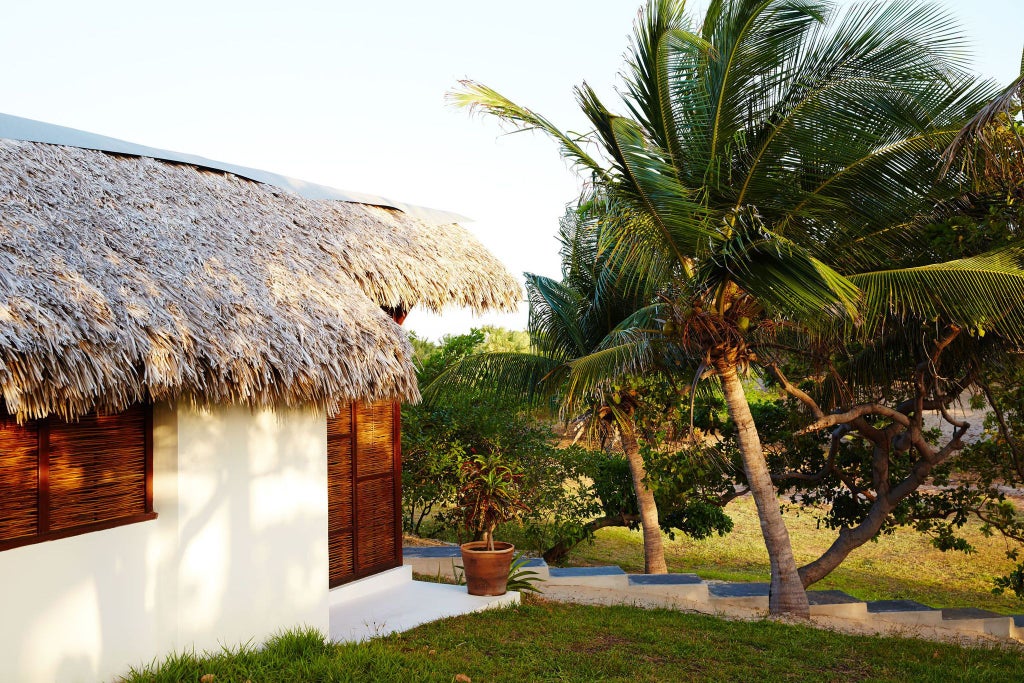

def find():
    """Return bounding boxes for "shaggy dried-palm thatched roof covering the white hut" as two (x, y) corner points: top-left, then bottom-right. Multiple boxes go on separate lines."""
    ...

(0, 140), (518, 418)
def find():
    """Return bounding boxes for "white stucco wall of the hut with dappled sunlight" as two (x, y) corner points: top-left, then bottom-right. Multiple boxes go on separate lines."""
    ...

(0, 405), (329, 683)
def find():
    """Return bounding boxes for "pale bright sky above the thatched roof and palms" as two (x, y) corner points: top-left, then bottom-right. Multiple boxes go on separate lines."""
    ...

(0, 0), (1024, 338)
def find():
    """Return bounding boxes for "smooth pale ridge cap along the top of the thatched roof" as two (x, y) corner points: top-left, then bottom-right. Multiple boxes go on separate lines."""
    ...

(0, 114), (469, 225)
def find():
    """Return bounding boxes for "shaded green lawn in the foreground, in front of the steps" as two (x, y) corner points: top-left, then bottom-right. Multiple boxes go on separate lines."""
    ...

(126, 600), (1024, 683)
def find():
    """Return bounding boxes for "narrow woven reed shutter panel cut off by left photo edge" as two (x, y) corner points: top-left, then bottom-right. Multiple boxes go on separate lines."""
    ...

(0, 416), (39, 541)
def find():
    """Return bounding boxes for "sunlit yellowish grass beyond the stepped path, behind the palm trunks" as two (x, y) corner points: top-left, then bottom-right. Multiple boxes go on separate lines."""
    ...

(568, 497), (1024, 613)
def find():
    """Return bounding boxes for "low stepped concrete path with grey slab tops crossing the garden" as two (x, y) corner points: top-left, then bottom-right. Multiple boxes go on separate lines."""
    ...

(402, 546), (1024, 642)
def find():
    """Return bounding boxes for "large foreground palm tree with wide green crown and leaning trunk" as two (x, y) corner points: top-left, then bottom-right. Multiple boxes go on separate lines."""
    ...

(451, 0), (1024, 615)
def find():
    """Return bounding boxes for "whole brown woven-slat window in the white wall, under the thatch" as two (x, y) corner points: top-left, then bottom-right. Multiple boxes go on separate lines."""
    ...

(0, 405), (157, 550)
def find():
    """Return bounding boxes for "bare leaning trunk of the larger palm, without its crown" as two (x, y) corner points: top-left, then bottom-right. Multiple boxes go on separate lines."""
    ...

(719, 366), (810, 618)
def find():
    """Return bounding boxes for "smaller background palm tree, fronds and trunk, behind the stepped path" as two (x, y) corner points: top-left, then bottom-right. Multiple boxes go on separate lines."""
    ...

(424, 210), (668, 573)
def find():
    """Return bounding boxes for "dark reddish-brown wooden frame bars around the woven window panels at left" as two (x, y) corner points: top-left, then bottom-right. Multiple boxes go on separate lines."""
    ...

(0, 403), (158, 552)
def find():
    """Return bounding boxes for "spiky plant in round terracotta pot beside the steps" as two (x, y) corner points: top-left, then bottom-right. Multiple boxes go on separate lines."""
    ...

(458, 449), (526, 595)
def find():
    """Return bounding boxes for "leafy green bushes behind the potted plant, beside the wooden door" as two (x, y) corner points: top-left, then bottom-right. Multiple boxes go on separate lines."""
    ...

(402, 328), (599, 551)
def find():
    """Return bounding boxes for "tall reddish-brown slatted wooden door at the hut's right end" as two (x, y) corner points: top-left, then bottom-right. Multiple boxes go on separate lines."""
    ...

(328, 402), (401, 587)
